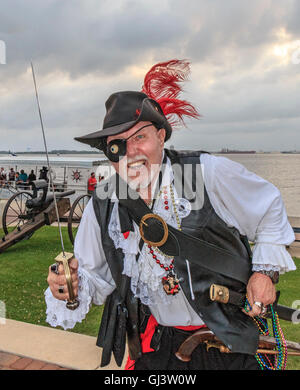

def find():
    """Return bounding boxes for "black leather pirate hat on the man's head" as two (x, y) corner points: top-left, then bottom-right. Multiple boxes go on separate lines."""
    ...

(75, 91), (172, 150)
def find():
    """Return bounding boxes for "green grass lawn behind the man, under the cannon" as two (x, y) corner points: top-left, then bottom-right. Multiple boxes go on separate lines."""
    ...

(0, 226), (300, 370)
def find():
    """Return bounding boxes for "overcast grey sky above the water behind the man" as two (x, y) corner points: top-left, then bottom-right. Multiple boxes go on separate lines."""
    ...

(0, 0), (300, 151)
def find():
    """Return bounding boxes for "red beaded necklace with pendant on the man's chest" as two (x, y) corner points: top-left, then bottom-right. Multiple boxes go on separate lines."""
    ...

(148, 184), (181, 295)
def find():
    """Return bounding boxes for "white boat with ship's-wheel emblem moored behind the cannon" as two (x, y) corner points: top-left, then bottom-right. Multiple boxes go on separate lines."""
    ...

(0, 154), (113, 199)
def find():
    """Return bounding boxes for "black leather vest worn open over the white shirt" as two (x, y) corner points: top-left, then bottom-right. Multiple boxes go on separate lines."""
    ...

(93, 150), (258, 366)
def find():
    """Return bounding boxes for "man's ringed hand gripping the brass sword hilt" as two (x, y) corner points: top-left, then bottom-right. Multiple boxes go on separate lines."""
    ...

(47, 258), (78, 301)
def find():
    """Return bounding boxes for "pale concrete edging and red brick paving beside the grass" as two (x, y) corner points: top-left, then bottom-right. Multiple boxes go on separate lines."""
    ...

(0, 319), (126, 370)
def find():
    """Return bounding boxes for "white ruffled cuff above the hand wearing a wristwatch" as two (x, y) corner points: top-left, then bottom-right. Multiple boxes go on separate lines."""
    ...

(252, 243), (296, 274)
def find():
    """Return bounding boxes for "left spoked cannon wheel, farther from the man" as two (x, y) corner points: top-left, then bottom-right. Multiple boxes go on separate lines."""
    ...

(2, 191), (33, 238)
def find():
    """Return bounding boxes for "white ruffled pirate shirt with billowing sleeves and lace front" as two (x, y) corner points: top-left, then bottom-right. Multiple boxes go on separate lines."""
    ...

(45, 154), (296, 329)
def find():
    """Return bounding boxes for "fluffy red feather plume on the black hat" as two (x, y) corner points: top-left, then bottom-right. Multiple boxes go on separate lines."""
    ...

(142, 59), (200, 126)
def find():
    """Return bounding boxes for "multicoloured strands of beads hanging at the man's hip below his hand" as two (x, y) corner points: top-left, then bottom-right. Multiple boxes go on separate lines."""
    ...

(244, 297), (287, 370)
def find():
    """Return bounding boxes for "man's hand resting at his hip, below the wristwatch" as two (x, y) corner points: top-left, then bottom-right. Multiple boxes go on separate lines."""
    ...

(244, 272), (276, 317)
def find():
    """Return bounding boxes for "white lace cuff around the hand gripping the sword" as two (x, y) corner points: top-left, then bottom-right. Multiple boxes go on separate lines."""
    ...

(45, 269), (94, 330)
